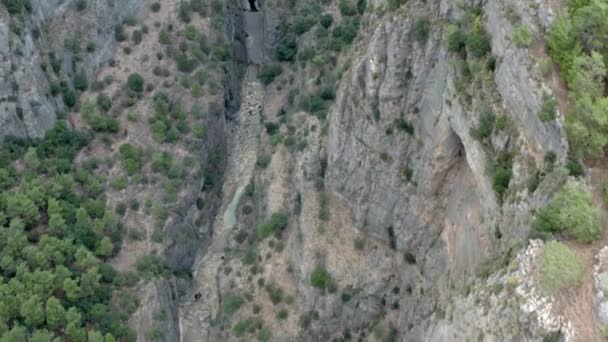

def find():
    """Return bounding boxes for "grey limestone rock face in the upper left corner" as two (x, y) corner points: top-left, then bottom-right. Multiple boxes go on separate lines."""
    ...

(0, 0), (147, 140)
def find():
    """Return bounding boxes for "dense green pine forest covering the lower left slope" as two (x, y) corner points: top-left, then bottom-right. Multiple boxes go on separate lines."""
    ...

(0, 122), (137, 341)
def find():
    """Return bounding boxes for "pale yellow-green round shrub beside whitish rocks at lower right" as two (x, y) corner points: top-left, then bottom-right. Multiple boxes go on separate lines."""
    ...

(541, 241), (585, 293)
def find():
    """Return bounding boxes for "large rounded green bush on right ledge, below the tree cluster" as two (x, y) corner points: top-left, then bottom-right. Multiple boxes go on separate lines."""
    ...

(532, 181), (602, 243)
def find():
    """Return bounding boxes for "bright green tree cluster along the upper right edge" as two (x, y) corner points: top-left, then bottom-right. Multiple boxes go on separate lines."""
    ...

(548, 0), (608, 157)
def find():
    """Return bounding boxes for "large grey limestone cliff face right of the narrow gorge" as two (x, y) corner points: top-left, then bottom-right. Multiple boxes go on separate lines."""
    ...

(326, 1), (566, 339)
